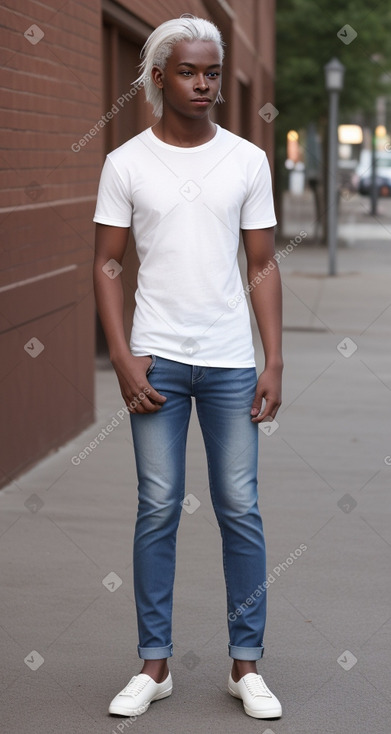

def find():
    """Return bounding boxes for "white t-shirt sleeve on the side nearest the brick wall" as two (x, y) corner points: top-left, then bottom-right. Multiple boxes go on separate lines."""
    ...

(93, 156), (133, 227)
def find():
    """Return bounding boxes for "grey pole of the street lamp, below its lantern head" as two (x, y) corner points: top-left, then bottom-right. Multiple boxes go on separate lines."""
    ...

(327, 91), (339, 275)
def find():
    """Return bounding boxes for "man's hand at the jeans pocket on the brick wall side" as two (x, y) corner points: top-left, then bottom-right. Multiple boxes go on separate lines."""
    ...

(111, 352), (167, 413)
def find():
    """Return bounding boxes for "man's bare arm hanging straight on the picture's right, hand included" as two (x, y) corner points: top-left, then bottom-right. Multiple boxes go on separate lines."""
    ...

(242, 227), (283, 423)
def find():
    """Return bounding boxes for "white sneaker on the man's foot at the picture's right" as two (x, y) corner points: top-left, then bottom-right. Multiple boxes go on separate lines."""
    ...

(228, 673), (282, 719)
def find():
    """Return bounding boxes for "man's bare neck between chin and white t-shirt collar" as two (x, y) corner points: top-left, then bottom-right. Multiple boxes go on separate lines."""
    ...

(152, 113), (216, 148)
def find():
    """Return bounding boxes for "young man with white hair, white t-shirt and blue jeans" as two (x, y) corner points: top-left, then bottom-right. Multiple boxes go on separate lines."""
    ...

(94, 16), (282, 719)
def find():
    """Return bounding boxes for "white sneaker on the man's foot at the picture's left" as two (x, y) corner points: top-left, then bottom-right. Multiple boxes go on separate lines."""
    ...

(109, 673), (172, 716)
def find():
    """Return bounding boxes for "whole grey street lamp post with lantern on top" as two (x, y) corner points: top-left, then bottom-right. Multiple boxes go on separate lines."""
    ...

(324, 58), (345, 275)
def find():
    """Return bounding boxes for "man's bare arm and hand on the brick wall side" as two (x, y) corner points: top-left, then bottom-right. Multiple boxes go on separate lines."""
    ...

(93, 224), (166, 413)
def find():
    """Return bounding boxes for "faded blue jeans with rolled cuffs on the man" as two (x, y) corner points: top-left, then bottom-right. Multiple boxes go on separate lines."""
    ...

(130, 355), (266, 660)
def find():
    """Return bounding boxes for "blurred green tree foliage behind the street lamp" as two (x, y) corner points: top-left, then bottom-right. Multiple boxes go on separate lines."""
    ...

(275, 0), (391, 134)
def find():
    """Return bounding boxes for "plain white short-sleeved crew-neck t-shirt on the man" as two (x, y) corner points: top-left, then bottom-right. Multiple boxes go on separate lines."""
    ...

(94, 125), (276, 367)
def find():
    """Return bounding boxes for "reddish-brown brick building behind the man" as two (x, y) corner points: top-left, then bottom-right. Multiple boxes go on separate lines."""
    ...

(0, 0), (275, 485)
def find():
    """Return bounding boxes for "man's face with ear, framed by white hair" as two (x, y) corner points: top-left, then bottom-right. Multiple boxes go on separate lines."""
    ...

(152, 41), (221, 119)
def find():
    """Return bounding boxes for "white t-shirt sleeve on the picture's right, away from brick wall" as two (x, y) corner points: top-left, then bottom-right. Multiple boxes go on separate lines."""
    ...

(240, 155), (277, 229)
